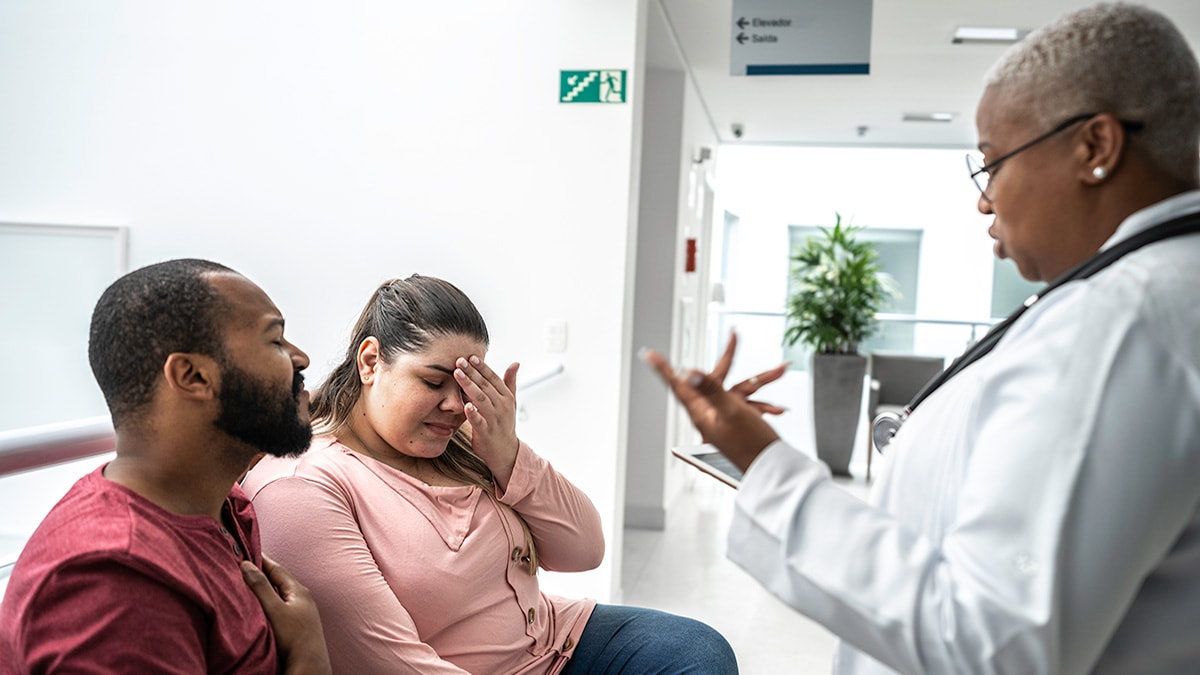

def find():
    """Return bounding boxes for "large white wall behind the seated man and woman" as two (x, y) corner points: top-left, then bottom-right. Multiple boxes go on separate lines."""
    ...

(0, 0), (644, 601)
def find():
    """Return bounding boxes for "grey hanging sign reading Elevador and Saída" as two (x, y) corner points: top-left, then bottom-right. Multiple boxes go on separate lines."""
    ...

(730, 0), (872, 74)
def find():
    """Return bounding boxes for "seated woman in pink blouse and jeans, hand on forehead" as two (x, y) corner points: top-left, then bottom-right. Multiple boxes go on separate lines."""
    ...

(242, 275), (737, 675)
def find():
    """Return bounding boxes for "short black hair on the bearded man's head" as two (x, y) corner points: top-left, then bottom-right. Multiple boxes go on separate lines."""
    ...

(88, 258), (236, 426)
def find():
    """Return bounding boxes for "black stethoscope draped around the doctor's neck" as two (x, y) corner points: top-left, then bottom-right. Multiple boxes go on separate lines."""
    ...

(871, 214), (1200, 453)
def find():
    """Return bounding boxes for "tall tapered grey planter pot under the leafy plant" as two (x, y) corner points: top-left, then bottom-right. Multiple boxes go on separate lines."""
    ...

(812, 353), (866, 476)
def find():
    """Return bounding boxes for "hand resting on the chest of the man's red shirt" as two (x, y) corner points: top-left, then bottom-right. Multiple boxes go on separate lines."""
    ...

(241, 555), (334, 675)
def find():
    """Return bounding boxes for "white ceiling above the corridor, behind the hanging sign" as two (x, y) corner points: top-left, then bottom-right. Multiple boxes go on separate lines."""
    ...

(647, 0), (1200, 147)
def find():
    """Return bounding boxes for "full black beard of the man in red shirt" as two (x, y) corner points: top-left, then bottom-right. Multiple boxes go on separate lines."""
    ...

(215, 363), (312, 456)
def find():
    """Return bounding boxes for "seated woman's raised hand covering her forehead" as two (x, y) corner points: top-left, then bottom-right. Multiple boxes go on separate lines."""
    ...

(454, 356), (521, 490)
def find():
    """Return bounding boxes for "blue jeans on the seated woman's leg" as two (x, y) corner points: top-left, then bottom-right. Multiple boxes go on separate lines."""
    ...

(563, 604), (738, 675)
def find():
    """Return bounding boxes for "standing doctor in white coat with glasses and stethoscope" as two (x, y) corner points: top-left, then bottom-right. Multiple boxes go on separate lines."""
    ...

(646, 4), (1200, 674)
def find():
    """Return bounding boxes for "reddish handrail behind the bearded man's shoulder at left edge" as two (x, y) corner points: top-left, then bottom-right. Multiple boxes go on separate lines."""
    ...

(0, 414), (116, 476)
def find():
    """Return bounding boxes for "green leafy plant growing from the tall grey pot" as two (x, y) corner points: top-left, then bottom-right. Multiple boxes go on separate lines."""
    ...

(784, 214), (899, 354)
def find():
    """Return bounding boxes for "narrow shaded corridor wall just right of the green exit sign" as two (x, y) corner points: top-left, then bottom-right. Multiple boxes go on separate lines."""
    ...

(625, 2), (718, 528)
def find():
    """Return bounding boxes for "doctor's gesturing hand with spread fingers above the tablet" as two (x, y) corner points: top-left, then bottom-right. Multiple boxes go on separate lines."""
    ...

(642, 334), (787, 471)
